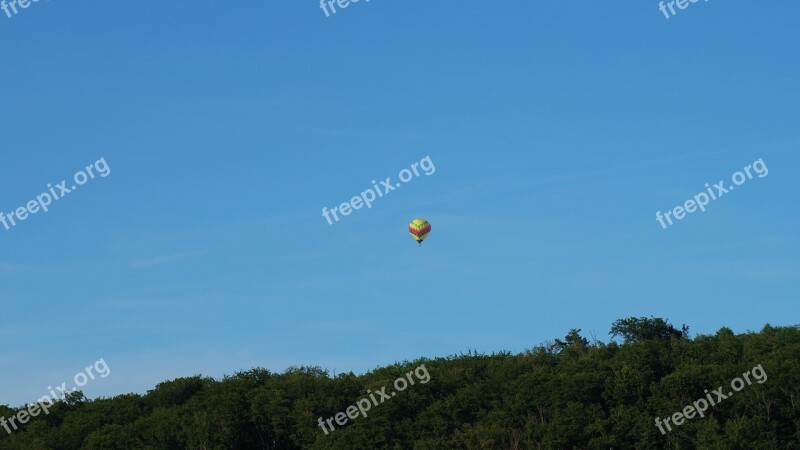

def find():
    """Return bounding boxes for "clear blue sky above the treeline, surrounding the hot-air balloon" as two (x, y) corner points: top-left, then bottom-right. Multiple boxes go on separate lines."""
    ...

(0, 0), (800, 405)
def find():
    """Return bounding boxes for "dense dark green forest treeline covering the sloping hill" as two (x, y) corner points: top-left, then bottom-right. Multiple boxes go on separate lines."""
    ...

(0, 318), (800, 450)
